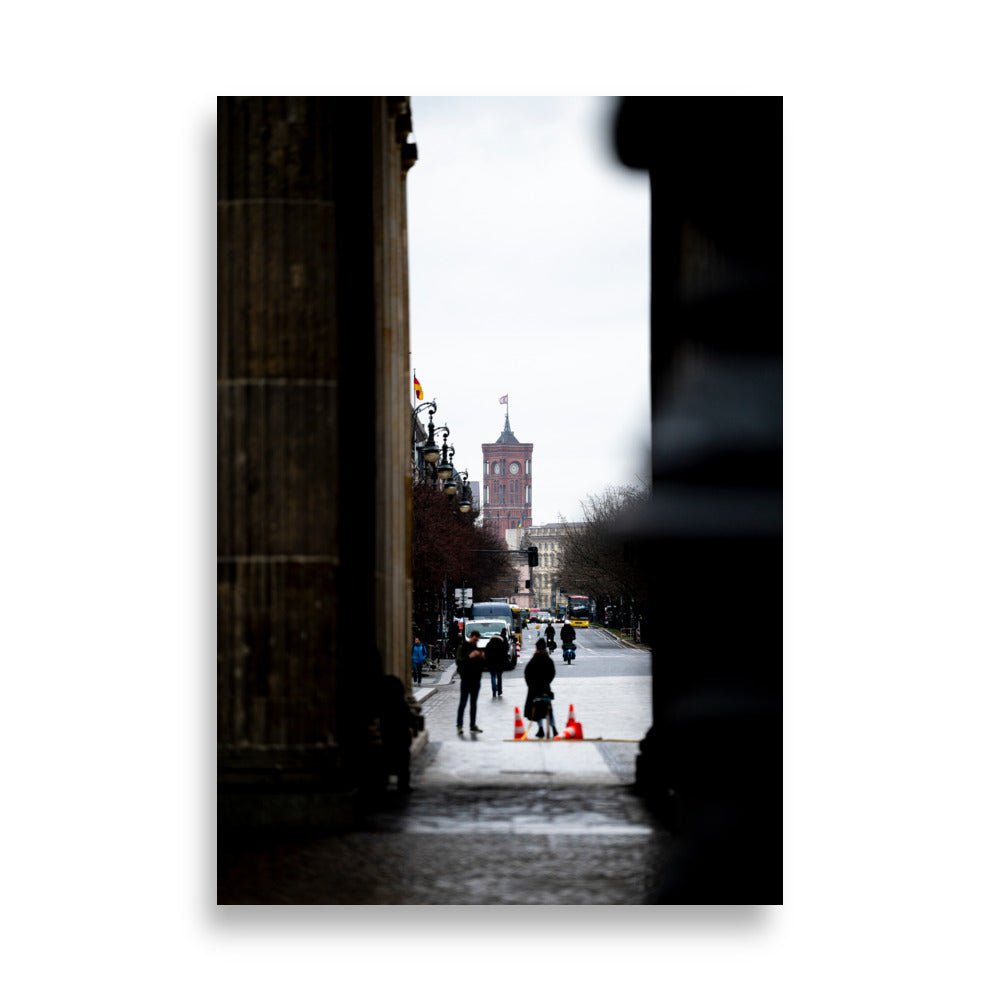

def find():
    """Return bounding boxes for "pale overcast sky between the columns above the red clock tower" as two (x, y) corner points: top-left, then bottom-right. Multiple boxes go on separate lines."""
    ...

(407, 96), (649, 524)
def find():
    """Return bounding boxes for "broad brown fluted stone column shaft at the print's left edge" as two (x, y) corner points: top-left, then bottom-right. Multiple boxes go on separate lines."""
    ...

(218, 98), (342, 748)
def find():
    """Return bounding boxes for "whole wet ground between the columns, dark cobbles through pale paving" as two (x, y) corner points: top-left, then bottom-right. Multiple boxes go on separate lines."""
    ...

(218, 649), (674, 905)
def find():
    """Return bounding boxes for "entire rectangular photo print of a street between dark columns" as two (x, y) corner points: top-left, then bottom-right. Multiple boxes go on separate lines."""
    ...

(216, 96), (783, 904)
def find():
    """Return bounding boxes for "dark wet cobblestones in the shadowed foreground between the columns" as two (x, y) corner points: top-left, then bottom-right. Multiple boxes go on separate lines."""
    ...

(219, 787), (670, 904)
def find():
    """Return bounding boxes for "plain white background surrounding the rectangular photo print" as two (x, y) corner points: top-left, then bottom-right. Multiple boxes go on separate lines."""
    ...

(0, 2), (1000, 1000)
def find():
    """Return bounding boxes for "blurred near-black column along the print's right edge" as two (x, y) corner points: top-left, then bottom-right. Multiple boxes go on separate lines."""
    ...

(617, 98), (782, 903)
